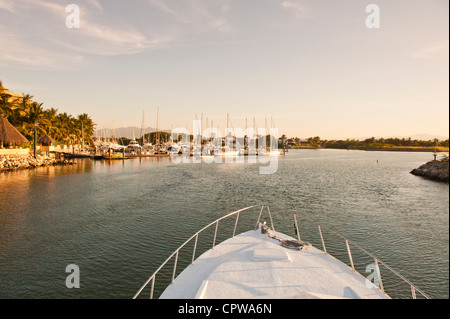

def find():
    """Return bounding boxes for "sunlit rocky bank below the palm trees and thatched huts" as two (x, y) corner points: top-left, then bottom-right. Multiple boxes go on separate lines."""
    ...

(0, 155), (73, 173)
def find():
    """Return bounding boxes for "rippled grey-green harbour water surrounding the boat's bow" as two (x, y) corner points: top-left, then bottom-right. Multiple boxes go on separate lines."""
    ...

(0, 150), (449, 298)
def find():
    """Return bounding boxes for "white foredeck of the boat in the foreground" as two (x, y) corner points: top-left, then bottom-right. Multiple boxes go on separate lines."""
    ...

(160, 230), (389, 299)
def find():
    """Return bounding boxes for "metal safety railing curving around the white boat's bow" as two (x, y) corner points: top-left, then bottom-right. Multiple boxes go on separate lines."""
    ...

(133, 205), (430, 299)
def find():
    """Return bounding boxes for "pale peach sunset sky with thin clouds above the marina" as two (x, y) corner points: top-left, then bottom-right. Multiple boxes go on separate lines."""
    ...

(0, 0), (449, 139)
